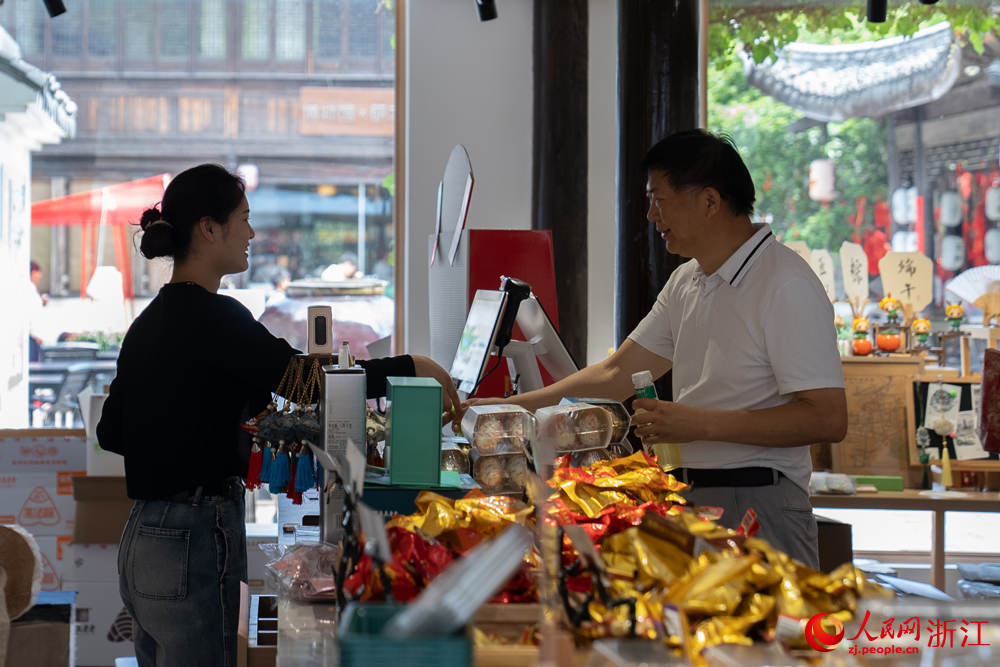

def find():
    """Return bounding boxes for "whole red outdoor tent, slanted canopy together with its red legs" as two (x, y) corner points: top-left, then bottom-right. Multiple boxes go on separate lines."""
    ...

(31, 174), (170, 299)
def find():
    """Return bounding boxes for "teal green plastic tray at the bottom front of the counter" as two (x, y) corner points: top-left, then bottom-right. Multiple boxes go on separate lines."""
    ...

(337, 602), (472, 667)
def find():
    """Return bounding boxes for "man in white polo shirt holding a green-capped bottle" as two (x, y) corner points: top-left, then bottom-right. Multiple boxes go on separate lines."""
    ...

(458, 130), (847, 567)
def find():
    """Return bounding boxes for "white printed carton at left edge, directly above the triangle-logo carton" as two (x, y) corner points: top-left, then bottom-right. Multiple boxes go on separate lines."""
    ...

(0, 428), (87, 474)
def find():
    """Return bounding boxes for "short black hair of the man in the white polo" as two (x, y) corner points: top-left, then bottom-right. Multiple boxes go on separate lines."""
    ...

(642, 129), (756, 215)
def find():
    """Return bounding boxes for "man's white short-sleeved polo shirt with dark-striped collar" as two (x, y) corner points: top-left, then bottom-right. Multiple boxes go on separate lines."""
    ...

(629, 225), (844, 491)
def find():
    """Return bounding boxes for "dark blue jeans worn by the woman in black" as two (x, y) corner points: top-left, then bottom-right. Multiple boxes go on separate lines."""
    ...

(118, 482), (247, 667)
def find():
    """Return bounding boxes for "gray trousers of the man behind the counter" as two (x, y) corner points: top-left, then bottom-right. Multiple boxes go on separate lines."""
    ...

(682, 475), (819, 570)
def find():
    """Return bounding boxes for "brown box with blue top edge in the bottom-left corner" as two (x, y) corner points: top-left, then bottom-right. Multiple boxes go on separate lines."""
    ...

(6, 592), (77, 667)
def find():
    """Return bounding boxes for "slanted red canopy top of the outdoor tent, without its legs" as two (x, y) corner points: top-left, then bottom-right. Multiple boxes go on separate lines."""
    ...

(31, 174), (170, 225)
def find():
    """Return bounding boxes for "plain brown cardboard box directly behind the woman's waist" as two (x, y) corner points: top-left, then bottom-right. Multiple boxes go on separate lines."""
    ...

(73, 477), (133, 544)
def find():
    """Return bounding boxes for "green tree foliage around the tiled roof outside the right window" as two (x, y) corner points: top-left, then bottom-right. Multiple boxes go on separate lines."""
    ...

(708, 0), (1000, 251)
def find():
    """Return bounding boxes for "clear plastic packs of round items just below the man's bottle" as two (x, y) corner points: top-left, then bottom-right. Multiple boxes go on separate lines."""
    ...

(535, 399), (628, 466)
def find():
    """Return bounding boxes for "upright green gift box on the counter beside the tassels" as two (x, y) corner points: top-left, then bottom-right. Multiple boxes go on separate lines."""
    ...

(386, 377), (443, 486)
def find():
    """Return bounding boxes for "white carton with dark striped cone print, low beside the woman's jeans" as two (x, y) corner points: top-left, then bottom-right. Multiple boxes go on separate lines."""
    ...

(63, 580), (135, 667)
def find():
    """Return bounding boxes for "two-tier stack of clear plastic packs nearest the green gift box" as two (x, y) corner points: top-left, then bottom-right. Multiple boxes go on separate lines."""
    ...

(462, 405), (535, 495)
